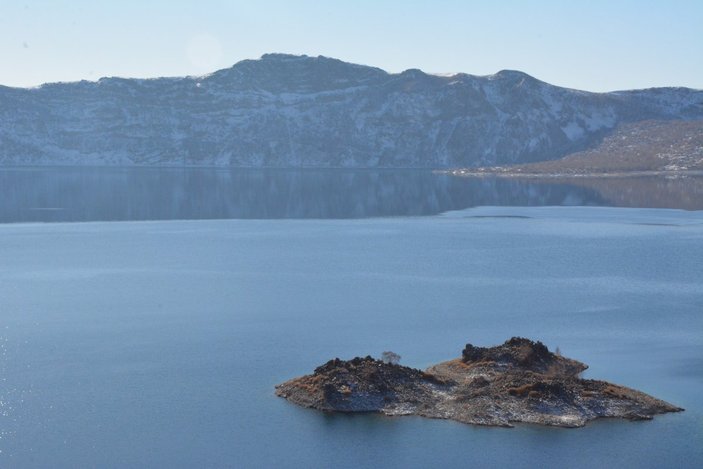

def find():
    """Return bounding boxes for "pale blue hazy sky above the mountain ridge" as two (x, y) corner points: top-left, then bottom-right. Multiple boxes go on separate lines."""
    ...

(0, 0), (703, 91)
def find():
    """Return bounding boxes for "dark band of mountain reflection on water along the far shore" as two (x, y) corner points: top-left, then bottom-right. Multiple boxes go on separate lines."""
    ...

(0, 167), (703, 223)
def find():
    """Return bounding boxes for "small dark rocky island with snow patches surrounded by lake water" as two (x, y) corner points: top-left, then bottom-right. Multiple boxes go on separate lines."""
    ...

(276, 337), (683, 427)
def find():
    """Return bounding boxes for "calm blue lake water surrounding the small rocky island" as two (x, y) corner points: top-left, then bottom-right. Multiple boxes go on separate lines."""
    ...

(0, 170), (703, 468)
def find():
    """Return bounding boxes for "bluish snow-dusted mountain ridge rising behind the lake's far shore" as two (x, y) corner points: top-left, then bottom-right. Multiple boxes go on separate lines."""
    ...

(0, 54), (703, 168)
